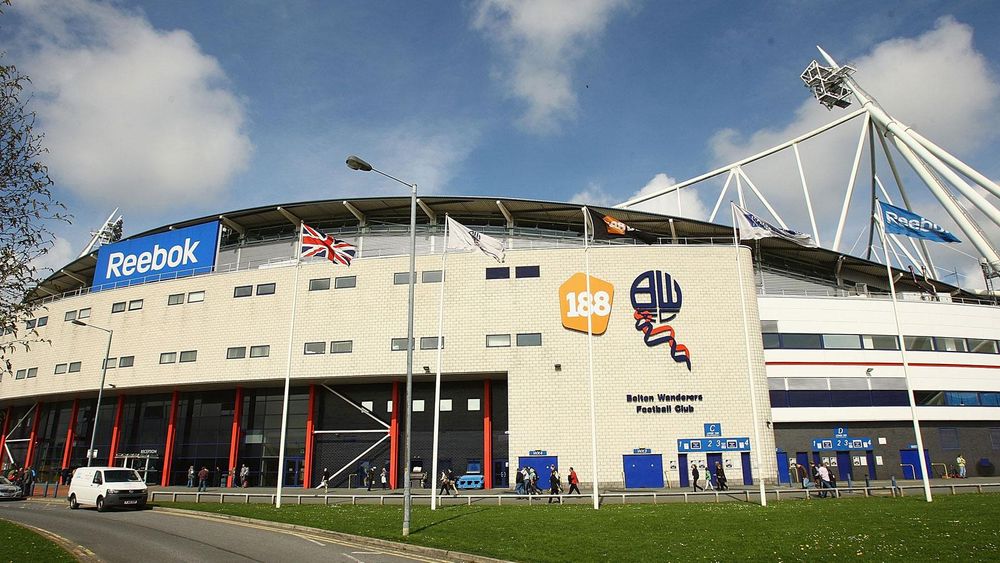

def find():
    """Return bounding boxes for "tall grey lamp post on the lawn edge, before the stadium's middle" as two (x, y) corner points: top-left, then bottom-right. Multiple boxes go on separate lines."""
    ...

(347, 155), (418, 536)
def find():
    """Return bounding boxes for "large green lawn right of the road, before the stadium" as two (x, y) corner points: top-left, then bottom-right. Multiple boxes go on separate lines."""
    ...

(159, 494), (1000, 561)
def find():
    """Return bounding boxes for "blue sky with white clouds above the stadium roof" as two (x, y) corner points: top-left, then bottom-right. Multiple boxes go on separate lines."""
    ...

(0, 0), (1000, 287)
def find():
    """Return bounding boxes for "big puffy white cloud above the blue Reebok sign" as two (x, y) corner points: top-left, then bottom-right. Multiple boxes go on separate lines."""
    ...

(14, 0), (252, 206)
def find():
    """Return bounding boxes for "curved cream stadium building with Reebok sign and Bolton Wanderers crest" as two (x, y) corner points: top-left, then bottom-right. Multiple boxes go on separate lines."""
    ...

(0, 196), (1000, 494)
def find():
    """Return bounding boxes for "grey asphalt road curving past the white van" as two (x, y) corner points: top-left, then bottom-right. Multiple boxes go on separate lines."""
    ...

(0, 500), (439, 563)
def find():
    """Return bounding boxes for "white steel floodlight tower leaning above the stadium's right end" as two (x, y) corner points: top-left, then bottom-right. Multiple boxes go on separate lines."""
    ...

(802, 46), (1000, 277)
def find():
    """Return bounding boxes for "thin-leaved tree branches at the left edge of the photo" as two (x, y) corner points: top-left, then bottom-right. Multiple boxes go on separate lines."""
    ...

(0, 55), (69, 374)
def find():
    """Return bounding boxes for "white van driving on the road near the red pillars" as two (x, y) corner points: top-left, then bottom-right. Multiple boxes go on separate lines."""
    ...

(69, 467), (149, 512)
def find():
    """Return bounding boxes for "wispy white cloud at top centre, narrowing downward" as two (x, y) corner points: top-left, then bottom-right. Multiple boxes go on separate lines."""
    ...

(472, 0), (627, 133)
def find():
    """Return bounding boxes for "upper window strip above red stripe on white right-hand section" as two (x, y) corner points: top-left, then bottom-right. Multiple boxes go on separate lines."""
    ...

(763, 332), (1000, 354)
